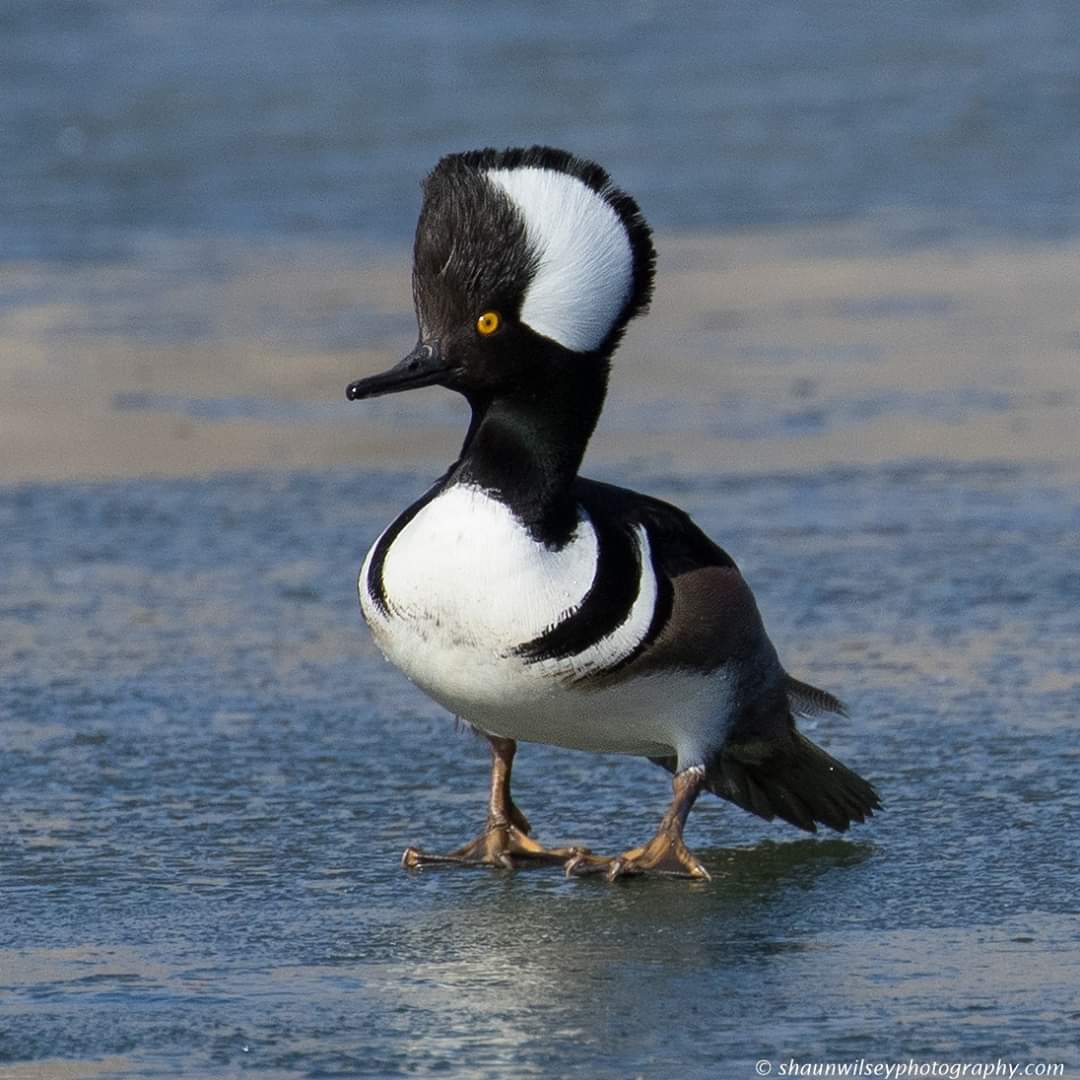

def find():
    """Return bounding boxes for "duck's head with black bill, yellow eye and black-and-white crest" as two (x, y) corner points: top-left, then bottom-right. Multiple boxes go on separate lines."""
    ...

(347, 147), (656, 402)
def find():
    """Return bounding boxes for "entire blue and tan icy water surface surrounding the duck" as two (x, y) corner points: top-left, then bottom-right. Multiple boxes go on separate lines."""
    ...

(0, 0), (1080, 1080)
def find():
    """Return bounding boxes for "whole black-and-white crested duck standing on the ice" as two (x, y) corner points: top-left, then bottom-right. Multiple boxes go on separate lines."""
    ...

(347, 147), (879, 878)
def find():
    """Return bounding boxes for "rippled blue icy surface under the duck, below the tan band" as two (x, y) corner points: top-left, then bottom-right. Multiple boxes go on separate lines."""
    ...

(6, 464), (1080, 1080)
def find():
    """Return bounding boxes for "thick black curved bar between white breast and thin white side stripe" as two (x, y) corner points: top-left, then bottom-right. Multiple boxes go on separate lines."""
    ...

(514, 516), (651, 663)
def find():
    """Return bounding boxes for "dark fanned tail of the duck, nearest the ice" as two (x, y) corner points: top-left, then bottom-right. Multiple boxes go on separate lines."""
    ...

(705, 734), (881, 833)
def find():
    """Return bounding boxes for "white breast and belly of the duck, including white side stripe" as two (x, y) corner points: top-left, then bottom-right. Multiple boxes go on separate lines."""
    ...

(360, 485), (728, 764)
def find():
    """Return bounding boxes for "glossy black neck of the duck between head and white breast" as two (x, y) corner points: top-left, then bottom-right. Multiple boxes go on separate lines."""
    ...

(448, 357), (607, 548)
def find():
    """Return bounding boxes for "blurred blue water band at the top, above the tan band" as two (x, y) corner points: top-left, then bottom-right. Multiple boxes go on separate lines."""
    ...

(6, 0), (1080, 259)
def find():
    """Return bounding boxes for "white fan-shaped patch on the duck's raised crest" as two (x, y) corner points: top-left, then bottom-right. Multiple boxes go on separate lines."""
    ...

(487, 165), (634, 352)
